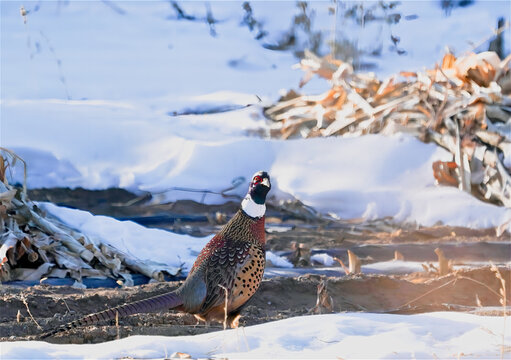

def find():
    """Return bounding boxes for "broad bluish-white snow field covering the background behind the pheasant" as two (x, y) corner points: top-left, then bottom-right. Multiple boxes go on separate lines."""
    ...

(0, 1), (511, 228)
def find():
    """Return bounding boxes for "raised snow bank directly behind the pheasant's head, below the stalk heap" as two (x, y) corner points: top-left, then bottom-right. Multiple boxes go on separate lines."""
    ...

(8, 131), (511, 228)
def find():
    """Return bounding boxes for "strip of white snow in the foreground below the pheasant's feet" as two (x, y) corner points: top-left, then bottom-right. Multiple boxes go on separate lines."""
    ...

(0, 312), (511, 359)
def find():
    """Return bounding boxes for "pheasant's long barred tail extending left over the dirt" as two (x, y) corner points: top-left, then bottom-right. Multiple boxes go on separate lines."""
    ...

(39, 292), (183, 339)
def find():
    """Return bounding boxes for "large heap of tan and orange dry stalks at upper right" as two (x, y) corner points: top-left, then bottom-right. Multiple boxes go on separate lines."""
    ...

(265, 52), (511, 207)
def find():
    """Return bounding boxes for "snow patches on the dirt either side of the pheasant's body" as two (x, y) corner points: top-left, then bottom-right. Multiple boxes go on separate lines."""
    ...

(41, 202), (476, 277)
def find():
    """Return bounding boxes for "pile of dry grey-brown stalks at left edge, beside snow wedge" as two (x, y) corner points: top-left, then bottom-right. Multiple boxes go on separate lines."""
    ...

(0, 148), (176, 287)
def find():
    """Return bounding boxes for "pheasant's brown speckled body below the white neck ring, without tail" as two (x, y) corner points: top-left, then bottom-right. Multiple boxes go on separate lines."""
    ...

(176, 210), (265, 322)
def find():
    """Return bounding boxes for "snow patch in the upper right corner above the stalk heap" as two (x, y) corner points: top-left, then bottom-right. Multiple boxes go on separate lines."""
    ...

(377, 0), (511, 76)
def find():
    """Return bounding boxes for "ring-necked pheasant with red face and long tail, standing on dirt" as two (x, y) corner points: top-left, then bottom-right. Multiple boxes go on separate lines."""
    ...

(39, 171), (271, 339)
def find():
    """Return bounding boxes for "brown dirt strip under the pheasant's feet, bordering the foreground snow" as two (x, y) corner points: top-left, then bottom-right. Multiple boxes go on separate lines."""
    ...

(0, 267), (511, 343)
